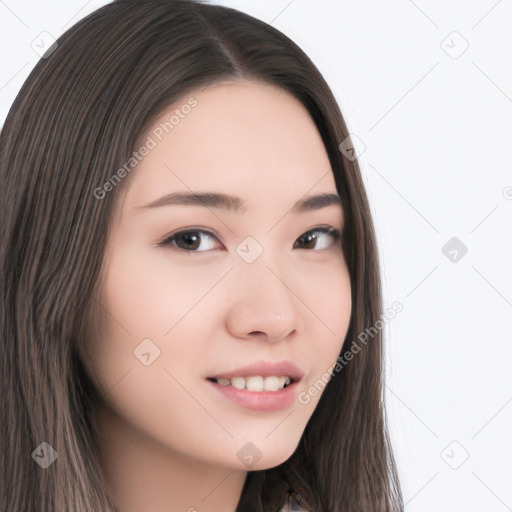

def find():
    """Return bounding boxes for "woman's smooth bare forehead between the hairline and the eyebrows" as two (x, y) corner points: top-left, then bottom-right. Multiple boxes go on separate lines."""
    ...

(120, 81), (336, 212)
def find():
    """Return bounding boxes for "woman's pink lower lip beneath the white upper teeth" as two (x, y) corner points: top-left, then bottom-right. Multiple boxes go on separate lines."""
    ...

(208, 380), (297, 412)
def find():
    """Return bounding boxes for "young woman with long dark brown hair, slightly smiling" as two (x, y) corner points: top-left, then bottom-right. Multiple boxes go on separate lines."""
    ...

(0, 0), (402, 512)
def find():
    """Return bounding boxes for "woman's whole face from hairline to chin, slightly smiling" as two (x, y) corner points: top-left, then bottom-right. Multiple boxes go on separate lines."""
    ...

(83, 82), (351, 470)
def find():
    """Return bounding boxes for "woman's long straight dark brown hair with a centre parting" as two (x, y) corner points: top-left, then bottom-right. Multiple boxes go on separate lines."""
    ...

(0, 0), (403, 512)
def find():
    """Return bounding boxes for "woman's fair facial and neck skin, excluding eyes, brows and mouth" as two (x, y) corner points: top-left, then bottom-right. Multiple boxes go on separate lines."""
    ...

(82, 81), (351, 512)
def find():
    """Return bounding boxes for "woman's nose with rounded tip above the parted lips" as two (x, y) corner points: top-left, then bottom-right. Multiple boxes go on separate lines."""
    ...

(226, 258), (305, 342)
